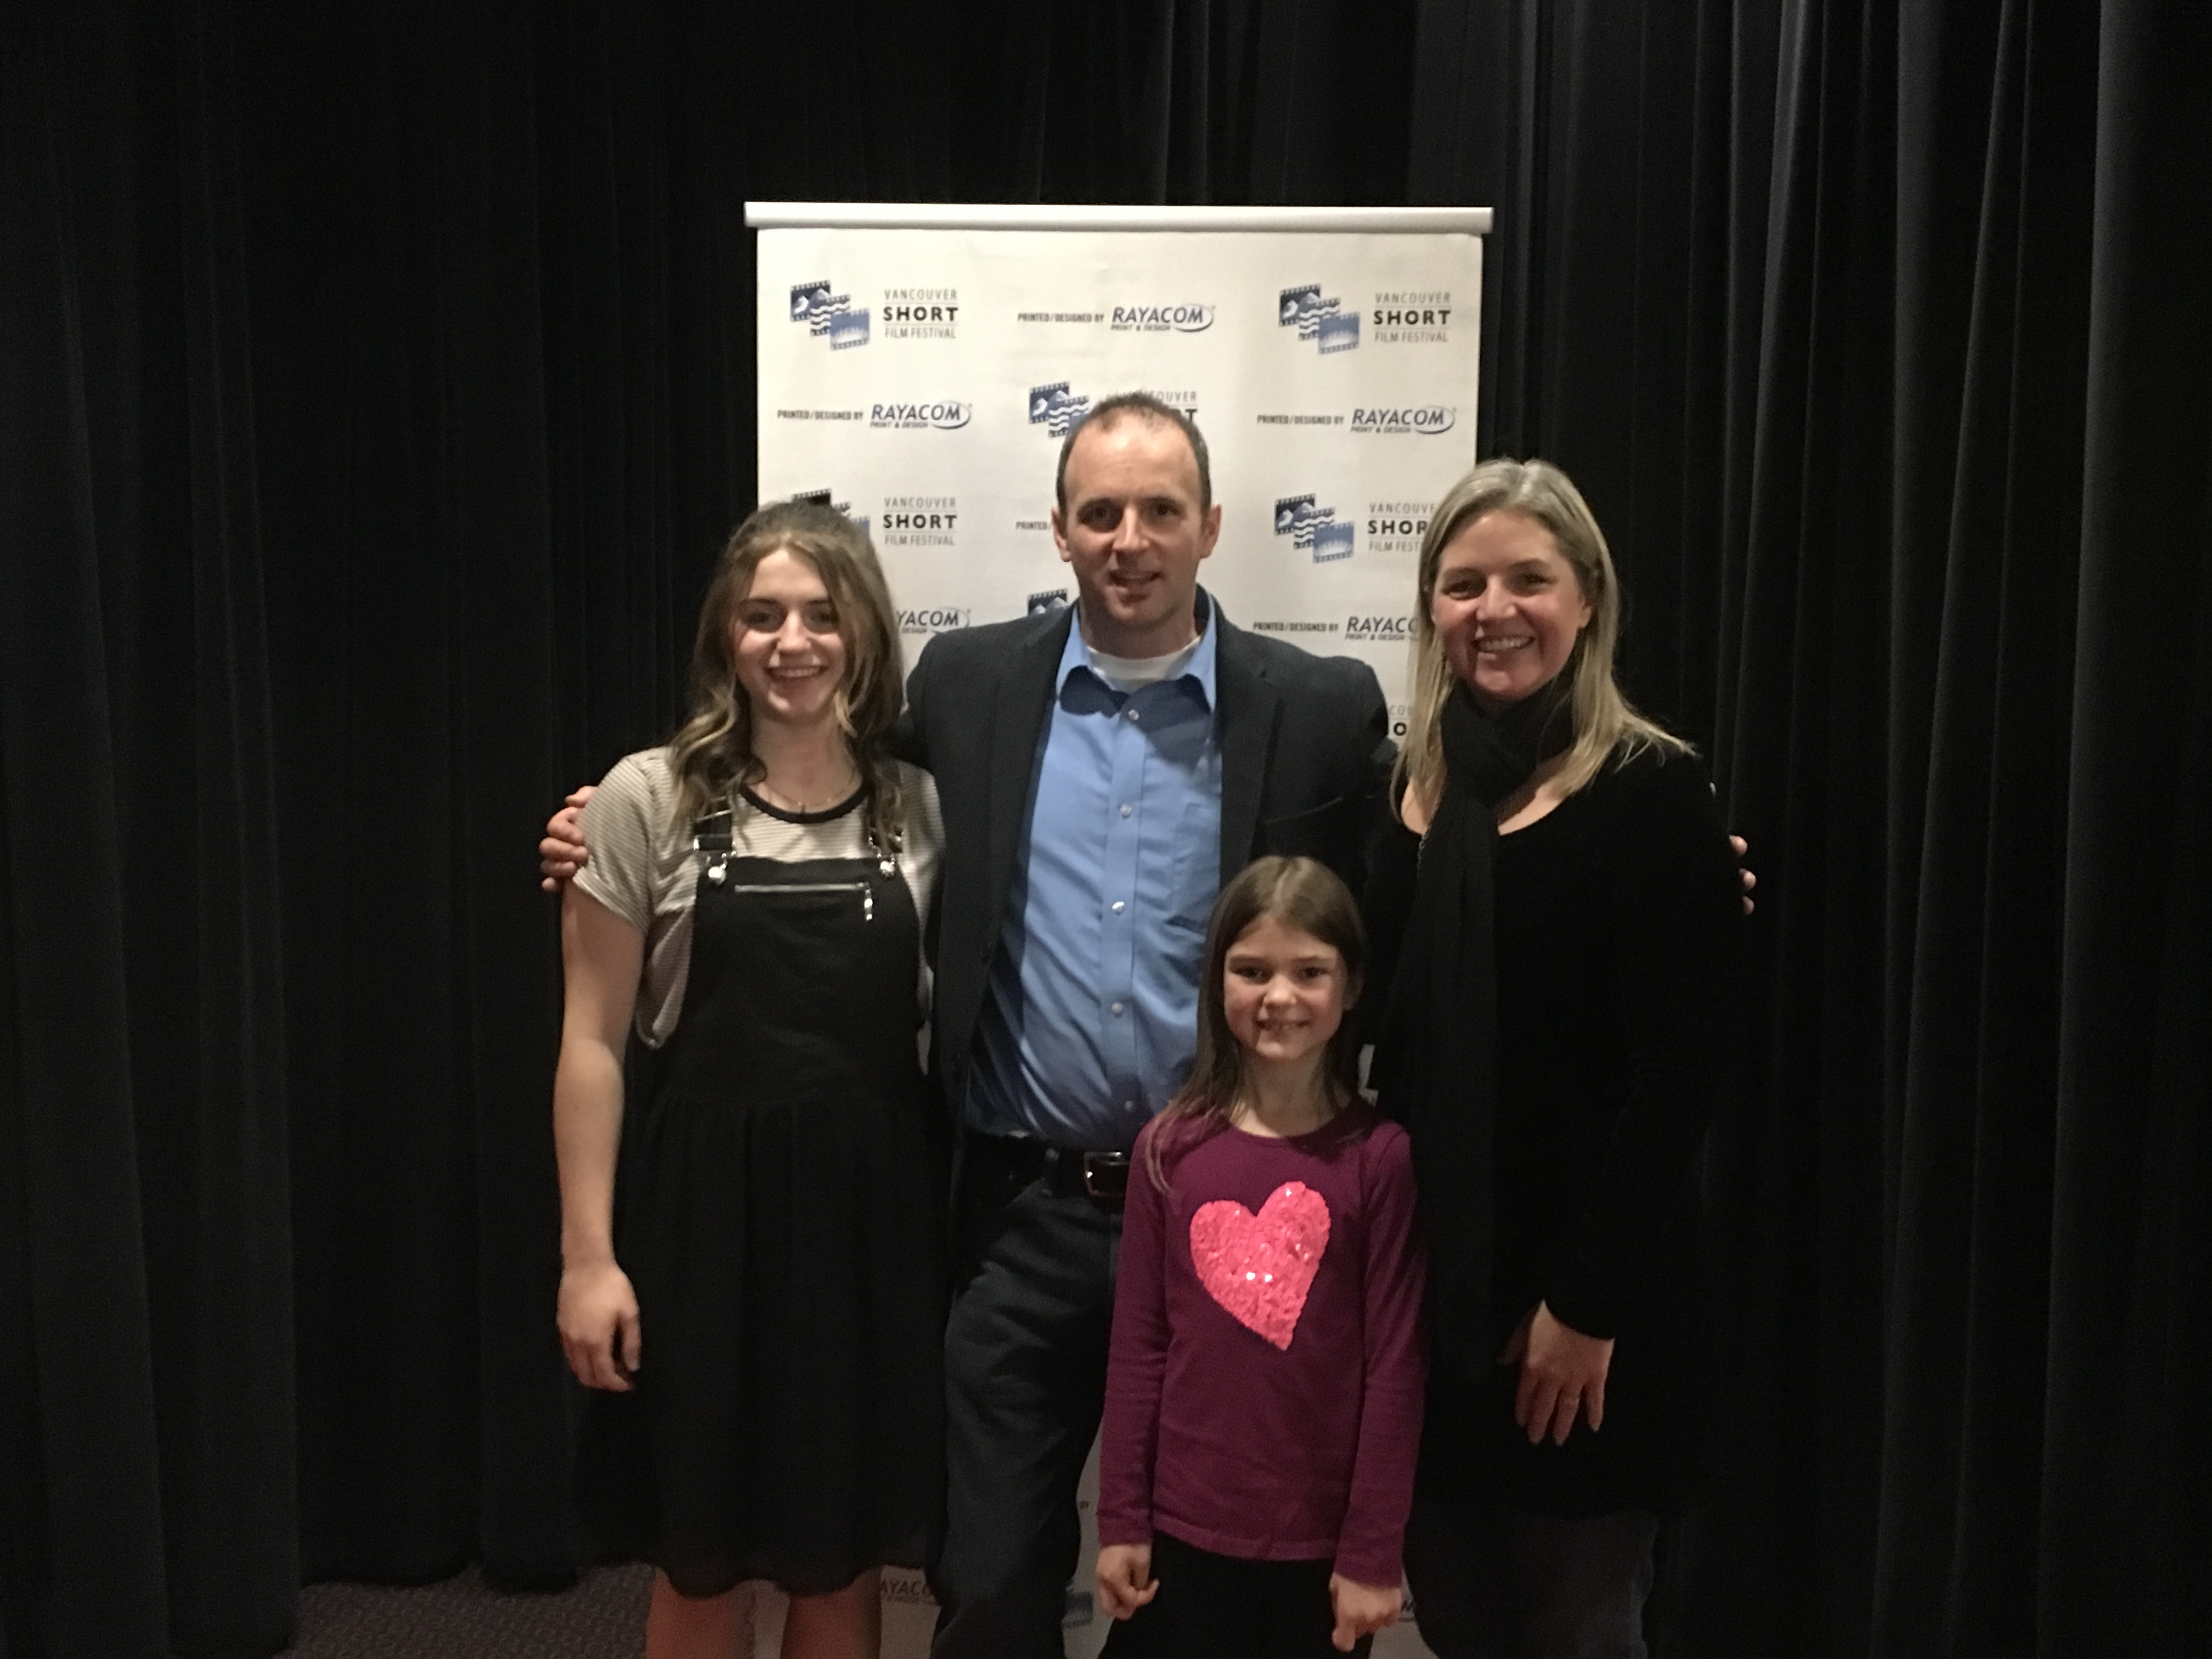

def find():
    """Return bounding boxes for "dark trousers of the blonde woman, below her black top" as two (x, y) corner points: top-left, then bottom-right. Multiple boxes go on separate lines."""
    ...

(1404, 1498), (1659, 1659)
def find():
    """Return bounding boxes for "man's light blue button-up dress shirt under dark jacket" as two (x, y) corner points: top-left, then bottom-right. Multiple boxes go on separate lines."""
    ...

(967, 597), (1221, 1150)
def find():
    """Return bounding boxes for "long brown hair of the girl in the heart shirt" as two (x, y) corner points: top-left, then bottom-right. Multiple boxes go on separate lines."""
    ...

(1144, 858), (1367, 1192)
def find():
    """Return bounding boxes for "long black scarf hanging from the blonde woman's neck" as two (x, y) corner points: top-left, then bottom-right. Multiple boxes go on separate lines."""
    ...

(1376, 675), (1575, 1380)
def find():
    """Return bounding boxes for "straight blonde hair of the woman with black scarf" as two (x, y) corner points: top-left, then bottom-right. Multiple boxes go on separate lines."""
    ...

(1396, 456), (1690, 822)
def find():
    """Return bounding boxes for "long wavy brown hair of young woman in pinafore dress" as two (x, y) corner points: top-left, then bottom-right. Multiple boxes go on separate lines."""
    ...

(668, 502), (907, 851)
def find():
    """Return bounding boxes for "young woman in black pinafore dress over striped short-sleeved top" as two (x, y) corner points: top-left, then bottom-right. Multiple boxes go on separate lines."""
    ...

(555, 502), (945, 1659)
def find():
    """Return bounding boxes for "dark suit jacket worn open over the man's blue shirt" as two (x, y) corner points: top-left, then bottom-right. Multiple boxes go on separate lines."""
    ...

(902, 606), (1391, 1132)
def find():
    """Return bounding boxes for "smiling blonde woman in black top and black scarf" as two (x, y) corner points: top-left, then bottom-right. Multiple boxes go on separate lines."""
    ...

(1369, 460), (1739, 1659)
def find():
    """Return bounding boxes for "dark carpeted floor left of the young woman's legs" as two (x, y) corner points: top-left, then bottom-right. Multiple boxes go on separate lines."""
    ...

(283, 1566), (652, 1659)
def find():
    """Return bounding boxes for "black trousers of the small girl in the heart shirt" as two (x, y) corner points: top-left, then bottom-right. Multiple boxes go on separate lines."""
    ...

(1104, 1533), (1374, 1659)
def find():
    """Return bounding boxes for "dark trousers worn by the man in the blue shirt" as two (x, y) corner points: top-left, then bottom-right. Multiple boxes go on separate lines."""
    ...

(929, 1166), (1121, 1659)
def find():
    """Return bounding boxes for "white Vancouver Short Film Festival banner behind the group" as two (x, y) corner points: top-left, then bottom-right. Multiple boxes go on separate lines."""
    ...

(746, 204), (1491, 1659)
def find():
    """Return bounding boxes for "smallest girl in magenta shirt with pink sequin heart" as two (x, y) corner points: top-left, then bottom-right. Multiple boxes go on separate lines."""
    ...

(1097, 858), (1423, 1659)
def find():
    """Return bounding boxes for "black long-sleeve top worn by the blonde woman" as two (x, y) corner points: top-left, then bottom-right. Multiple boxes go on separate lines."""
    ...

(1378, 750), (1741, 1513)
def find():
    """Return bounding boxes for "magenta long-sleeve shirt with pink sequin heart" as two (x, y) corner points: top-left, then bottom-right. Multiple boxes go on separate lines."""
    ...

(1099, 1124), (1423, 1584)
